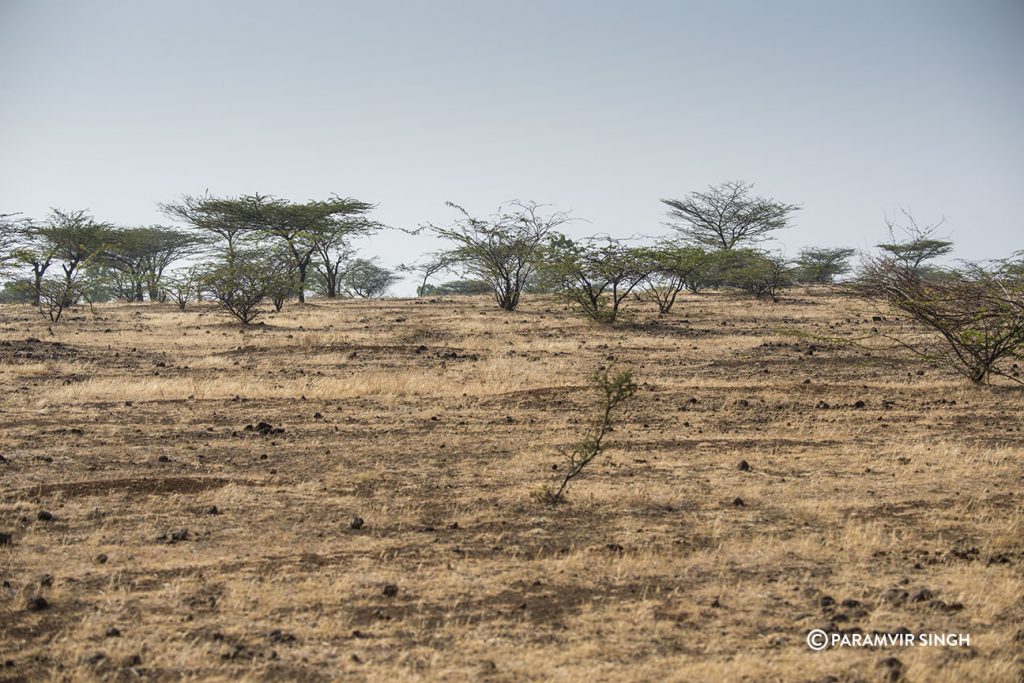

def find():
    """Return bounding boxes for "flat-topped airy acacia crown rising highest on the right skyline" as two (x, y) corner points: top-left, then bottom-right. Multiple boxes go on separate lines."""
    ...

(662, 180), (800, 250)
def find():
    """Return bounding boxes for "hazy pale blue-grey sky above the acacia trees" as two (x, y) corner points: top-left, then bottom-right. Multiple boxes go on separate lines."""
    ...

(0, 0), (1024, 293)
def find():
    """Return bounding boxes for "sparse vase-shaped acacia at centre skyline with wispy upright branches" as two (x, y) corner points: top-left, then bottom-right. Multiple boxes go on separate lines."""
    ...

(426, 201), (569, 310)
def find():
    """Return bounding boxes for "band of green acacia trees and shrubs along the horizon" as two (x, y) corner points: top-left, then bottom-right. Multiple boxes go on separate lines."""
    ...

(0, 180), (1024, 382)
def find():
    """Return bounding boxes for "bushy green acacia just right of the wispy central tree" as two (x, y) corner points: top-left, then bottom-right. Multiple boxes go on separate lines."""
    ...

(542, 234), (656, 325)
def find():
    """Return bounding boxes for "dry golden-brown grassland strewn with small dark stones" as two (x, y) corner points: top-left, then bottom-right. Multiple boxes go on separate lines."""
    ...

(0, 291), (1024, 682)
